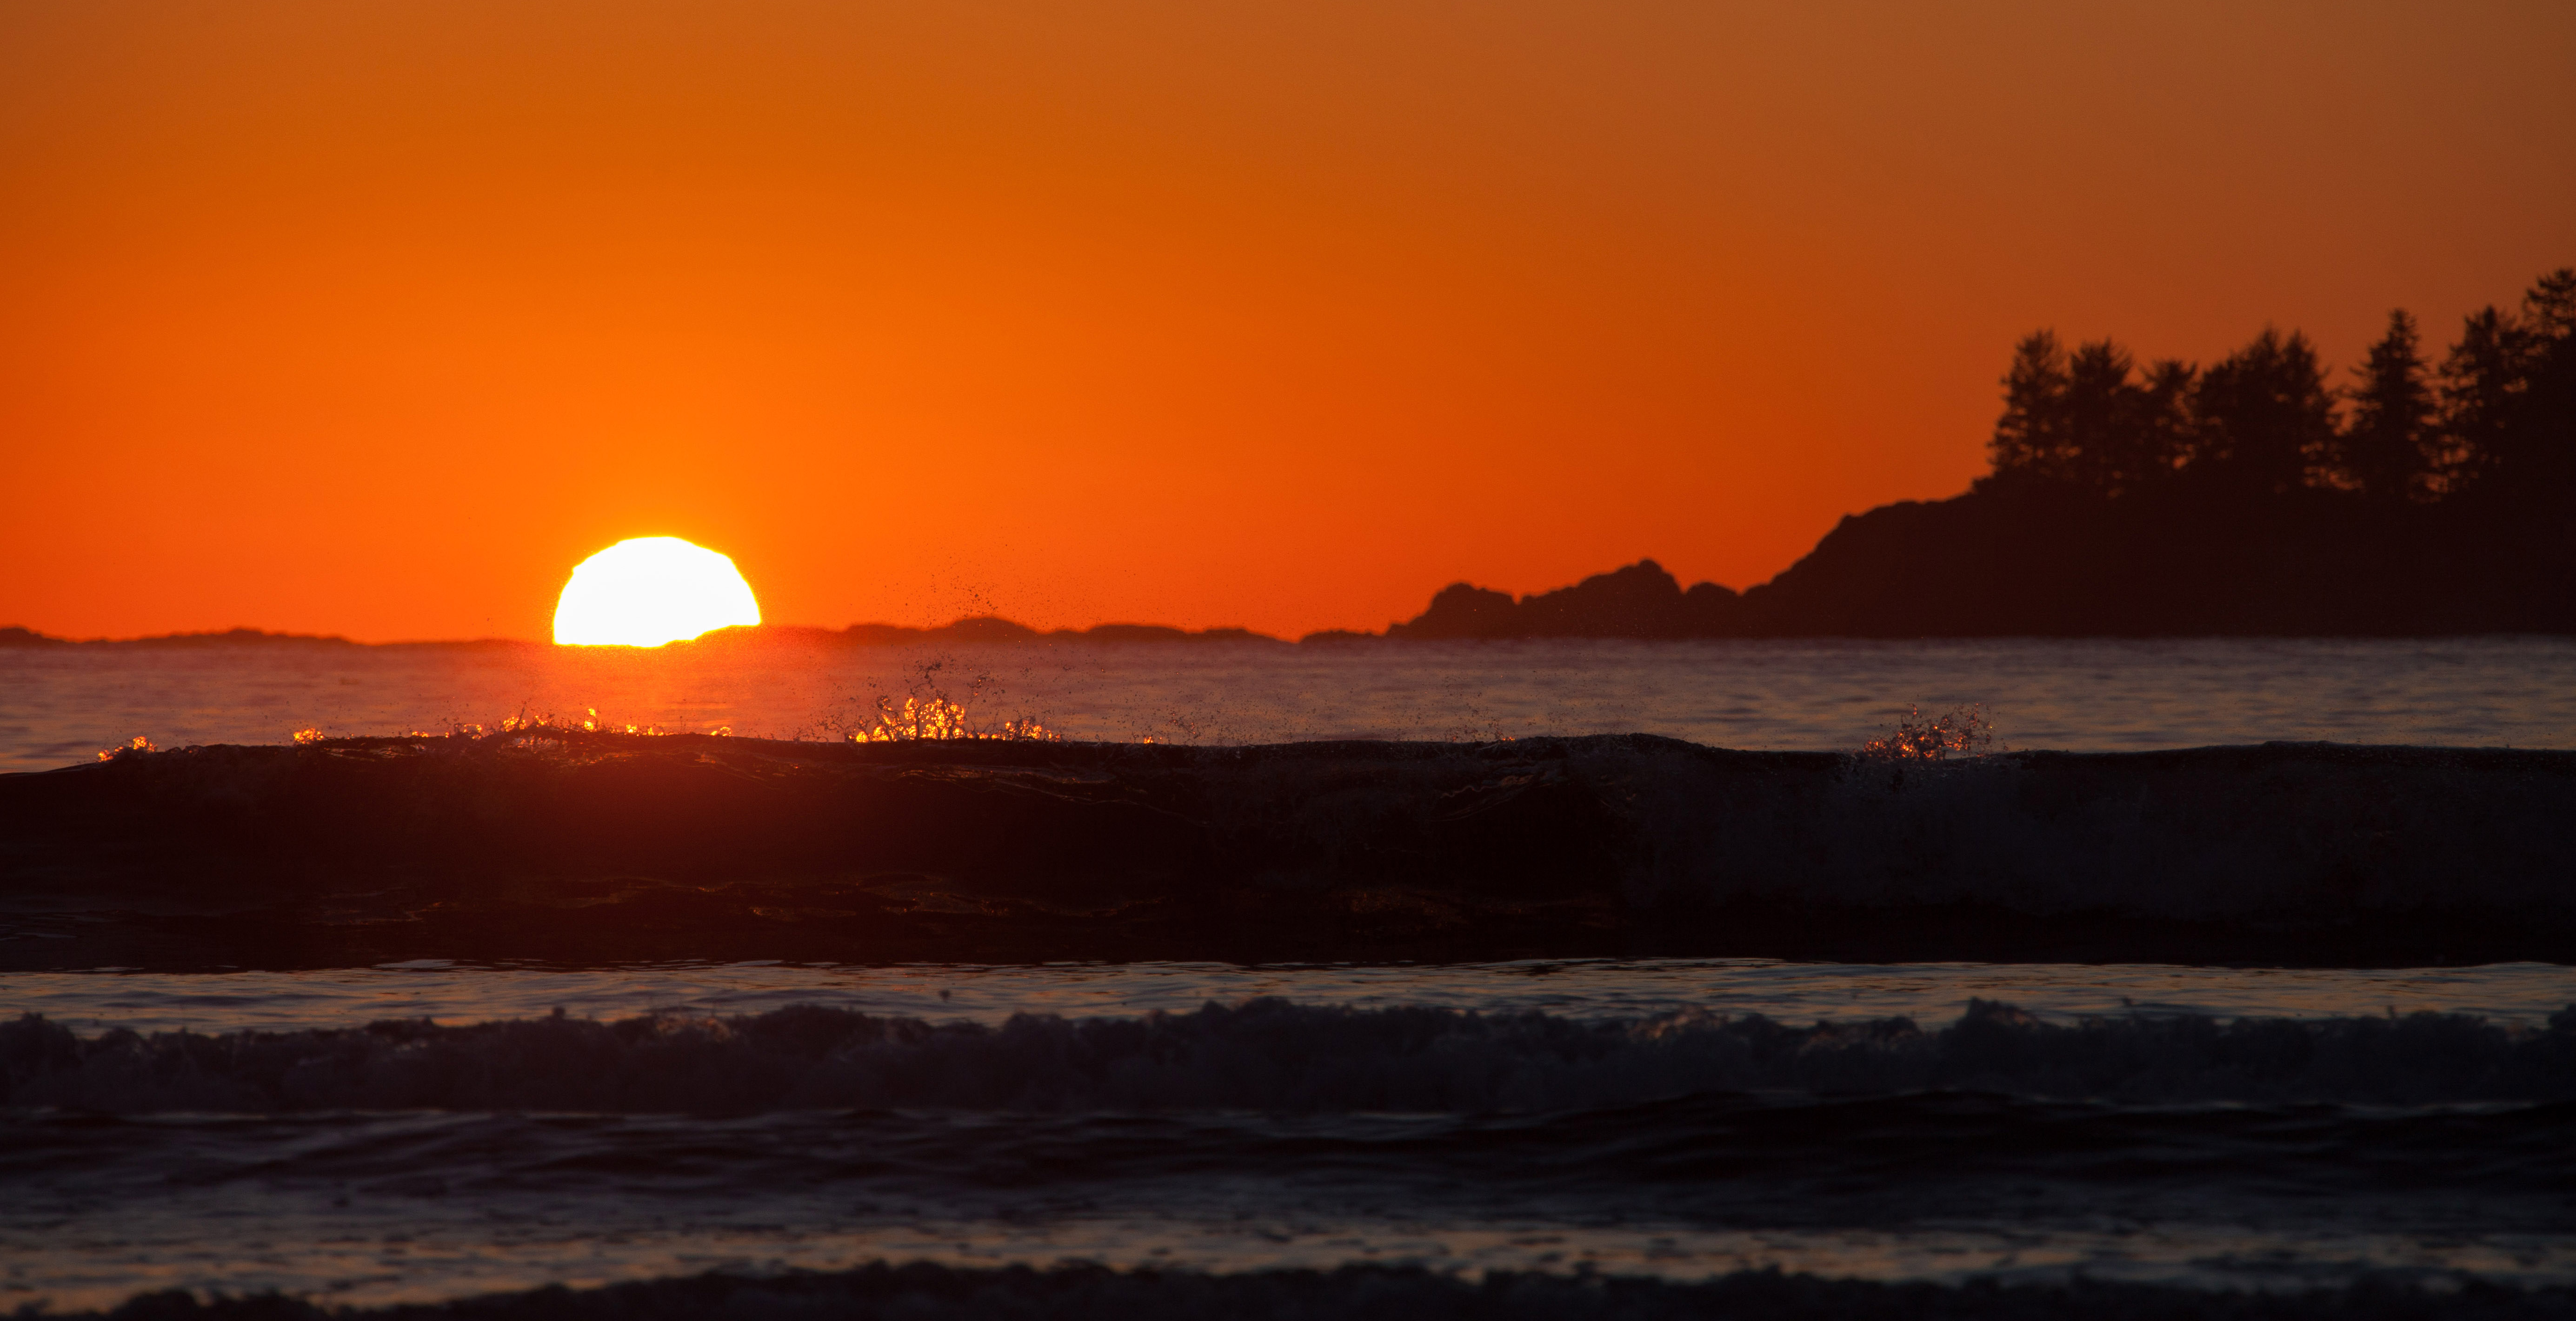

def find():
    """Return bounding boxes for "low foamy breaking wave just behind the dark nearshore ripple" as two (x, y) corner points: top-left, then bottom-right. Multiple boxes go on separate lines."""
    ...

(0, 999), (2576, 1113)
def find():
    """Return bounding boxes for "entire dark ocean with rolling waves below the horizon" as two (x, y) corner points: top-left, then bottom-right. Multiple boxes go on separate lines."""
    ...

(0, 639), (2576, 1318)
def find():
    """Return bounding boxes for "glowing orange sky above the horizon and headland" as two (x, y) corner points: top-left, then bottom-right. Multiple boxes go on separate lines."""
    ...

(0, 0), (2576, 639)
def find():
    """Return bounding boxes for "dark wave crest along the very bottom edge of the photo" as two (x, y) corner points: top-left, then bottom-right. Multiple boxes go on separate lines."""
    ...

(55, 1262), (2576, 1321)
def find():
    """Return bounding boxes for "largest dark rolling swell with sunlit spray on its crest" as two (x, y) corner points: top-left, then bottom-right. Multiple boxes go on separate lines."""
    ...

(0, 731), (2576, 968)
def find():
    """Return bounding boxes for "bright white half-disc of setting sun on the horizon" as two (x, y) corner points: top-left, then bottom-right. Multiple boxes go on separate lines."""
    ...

(554, 536), (760, 647)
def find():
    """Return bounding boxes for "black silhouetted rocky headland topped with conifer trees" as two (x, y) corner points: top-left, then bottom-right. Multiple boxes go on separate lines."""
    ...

(1389, 270), (2576, 639)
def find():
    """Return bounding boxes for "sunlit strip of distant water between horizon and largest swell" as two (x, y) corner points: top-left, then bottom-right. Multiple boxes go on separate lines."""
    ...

(0, 639), (2576, 770)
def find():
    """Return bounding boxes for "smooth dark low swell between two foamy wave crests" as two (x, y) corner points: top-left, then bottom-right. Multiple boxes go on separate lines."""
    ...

(25, 1092), (2576, 1210)
